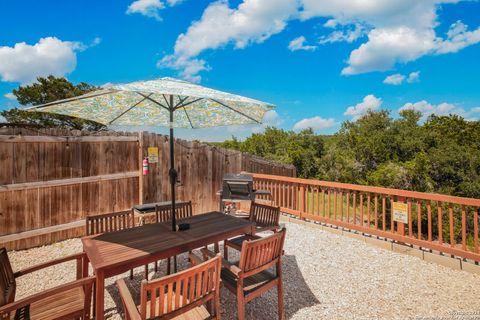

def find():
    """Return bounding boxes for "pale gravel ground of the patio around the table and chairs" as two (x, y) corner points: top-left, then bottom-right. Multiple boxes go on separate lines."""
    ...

(9, 223), (480, 319)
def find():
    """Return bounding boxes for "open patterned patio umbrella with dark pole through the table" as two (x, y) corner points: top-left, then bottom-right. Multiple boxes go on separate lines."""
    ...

(28, 78), (274, 231)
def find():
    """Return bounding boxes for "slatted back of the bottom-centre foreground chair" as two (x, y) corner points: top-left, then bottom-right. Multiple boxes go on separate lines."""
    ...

(140, 256), (222, 319)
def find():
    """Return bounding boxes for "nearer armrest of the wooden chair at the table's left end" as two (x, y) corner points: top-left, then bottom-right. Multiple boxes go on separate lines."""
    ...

(0, 277), (96, 319)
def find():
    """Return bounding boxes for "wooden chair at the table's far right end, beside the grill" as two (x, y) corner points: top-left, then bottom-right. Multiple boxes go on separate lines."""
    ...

(223, 202), (280, 259)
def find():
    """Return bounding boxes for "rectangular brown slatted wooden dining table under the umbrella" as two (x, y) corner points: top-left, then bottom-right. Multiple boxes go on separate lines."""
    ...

(82, 212), (255, 319)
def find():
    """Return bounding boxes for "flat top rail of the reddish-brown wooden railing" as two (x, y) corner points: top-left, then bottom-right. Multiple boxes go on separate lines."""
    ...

(252, 173), (480, 207)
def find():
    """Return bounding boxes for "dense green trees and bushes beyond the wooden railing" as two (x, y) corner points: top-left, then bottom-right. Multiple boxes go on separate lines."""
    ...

(220, 110), (480, 198)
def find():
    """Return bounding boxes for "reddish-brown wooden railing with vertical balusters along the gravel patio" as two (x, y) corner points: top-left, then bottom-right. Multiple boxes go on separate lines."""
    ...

(253, 174), (480, 261)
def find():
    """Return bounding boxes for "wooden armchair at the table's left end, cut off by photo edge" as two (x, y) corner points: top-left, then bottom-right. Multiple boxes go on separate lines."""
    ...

(0, 248), (95, 320)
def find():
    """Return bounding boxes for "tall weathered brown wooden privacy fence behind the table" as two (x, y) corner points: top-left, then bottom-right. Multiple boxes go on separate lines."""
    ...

(0, 128), (295, 249)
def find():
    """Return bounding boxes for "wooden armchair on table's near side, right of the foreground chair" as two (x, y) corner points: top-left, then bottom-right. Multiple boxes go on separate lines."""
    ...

(201, 229), (286, 320)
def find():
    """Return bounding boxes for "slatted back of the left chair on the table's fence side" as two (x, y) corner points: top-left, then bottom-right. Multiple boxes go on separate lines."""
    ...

(85, 210), (135, 236)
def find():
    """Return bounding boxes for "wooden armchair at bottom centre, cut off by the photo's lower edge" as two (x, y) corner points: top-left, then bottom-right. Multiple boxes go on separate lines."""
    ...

(117, 255), (221, 320)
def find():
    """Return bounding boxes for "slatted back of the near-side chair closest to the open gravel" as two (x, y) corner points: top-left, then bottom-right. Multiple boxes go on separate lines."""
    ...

(239, 229), (286, 277)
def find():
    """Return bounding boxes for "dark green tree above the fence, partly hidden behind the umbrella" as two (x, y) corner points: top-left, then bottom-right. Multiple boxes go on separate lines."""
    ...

(1, 76), (105, 130)
